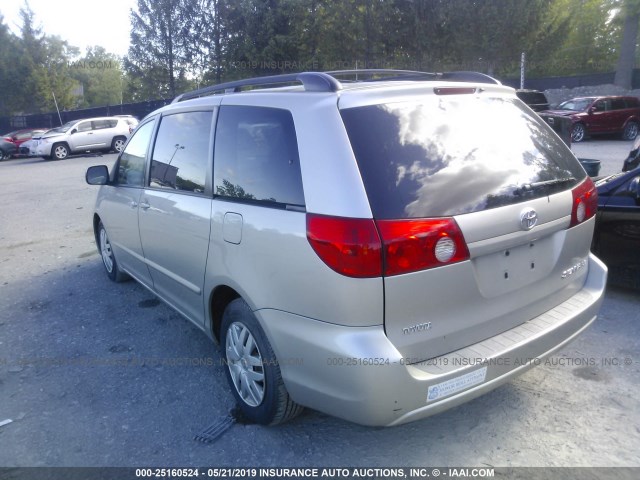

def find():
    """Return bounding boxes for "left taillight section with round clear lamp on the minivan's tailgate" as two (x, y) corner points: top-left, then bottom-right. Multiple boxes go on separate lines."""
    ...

(376, 218), (469, 276)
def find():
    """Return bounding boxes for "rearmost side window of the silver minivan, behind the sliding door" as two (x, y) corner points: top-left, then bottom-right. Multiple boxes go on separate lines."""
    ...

(213, 105), (304, 206)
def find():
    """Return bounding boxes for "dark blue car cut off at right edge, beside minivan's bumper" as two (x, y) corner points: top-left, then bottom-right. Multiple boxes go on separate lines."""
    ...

(591, 168), (640, 288)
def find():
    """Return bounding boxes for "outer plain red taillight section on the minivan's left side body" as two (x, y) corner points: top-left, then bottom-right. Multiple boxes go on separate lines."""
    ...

(307, 214), (382, 278)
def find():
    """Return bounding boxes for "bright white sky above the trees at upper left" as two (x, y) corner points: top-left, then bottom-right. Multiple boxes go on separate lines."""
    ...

(0, 0), (137, 56)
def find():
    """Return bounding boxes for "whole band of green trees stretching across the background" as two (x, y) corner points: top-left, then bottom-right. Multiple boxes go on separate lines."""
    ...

(0, 0), (640, 115)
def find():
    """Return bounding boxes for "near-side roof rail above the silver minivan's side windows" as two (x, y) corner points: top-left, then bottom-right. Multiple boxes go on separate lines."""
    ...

(171, 72), (342, 103)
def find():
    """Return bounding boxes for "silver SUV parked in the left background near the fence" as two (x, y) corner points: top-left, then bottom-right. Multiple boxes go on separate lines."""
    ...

(29, 117), (133, 160)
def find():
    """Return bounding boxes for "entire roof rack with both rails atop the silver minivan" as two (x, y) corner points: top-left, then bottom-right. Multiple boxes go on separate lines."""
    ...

(171, 69), (501, 103)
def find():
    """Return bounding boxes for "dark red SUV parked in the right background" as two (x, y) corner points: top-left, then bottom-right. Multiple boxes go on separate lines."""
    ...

(545, 97), (640, 142)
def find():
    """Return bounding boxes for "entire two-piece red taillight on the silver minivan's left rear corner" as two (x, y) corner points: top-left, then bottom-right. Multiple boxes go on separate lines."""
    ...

(307, 214), (469, 278)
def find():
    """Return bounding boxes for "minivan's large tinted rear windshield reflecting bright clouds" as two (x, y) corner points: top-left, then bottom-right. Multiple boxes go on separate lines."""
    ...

(341, 95), (585, 219)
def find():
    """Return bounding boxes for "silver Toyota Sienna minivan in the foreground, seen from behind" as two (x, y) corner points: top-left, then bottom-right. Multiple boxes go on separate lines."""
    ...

(87, 71), (607, 425)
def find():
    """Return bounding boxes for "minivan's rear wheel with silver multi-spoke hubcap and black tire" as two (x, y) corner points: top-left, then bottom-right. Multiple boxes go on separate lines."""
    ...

(220, 298), (303, 425)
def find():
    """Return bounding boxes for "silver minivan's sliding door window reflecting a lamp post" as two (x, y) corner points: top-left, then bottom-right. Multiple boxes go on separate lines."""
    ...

(149, 111), (213, 193)
